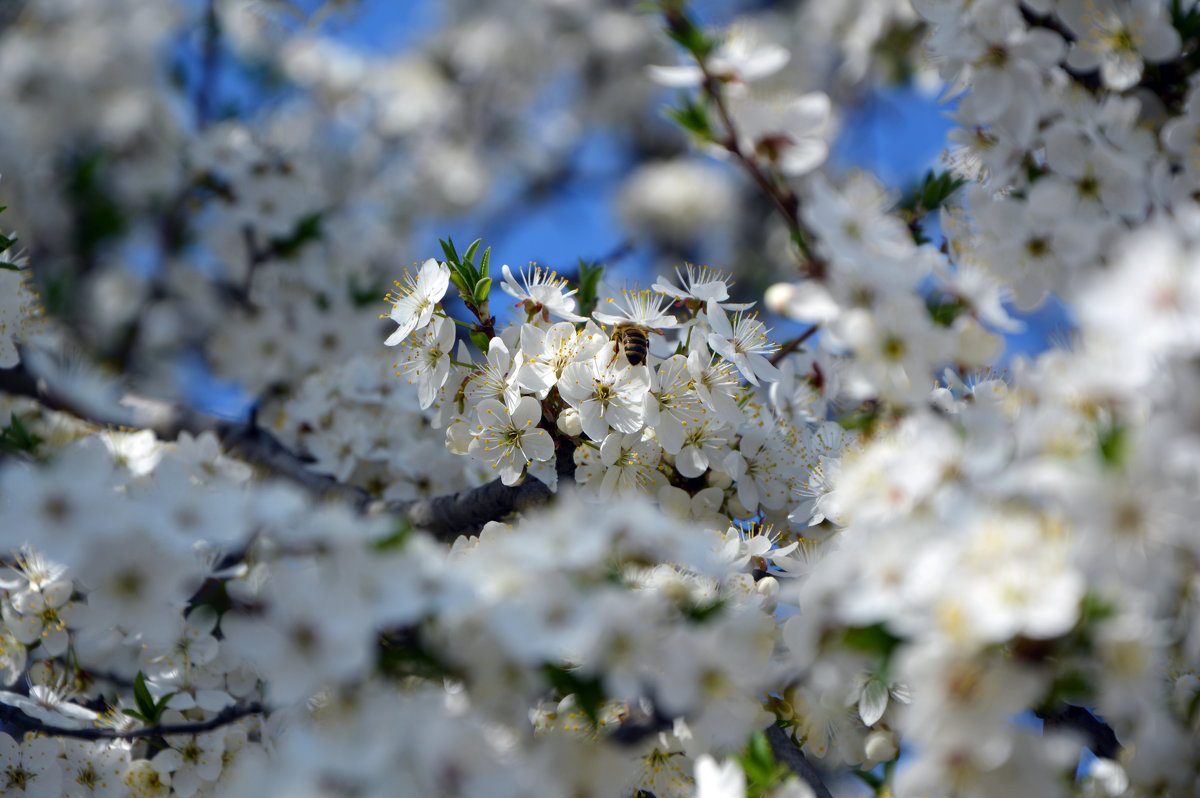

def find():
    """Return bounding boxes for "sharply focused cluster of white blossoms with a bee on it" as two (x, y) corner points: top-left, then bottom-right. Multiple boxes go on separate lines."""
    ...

(388, 259), (840, 529)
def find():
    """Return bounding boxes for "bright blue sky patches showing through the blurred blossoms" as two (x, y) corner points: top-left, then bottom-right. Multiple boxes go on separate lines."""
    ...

(181, 0), (1067, 415)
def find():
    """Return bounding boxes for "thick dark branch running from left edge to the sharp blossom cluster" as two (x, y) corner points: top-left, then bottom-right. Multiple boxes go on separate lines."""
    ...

(0, 353), (551, 541)
